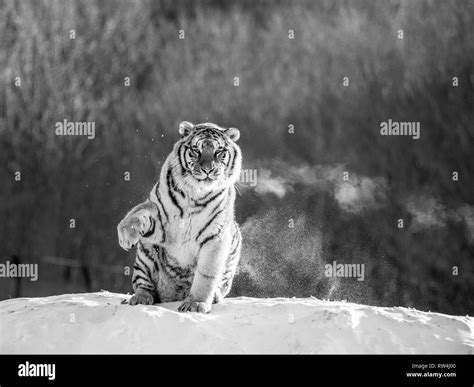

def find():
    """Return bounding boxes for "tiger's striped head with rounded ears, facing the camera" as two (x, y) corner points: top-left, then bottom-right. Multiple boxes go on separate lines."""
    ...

(174, 121), (242, 191)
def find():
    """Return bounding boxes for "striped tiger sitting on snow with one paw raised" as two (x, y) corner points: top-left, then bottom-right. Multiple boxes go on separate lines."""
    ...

(117, 121), (242, 313)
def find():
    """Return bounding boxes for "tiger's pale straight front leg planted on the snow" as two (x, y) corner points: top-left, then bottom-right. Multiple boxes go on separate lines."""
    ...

(178, 230), (231, 313)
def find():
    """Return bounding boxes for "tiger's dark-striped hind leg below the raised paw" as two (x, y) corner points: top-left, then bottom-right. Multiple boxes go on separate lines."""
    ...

(128, 243), (160, 305)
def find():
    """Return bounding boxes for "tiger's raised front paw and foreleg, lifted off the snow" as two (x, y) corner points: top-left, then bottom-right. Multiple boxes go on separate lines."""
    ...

(117, 200), (159, 251)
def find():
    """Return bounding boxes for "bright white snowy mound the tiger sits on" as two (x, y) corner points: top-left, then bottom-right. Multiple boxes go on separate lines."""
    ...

(0, 292), (474, 354)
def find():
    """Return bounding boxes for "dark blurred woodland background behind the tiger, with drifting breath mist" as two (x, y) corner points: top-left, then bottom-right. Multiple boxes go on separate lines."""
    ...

(0, 0), (474, 315)
